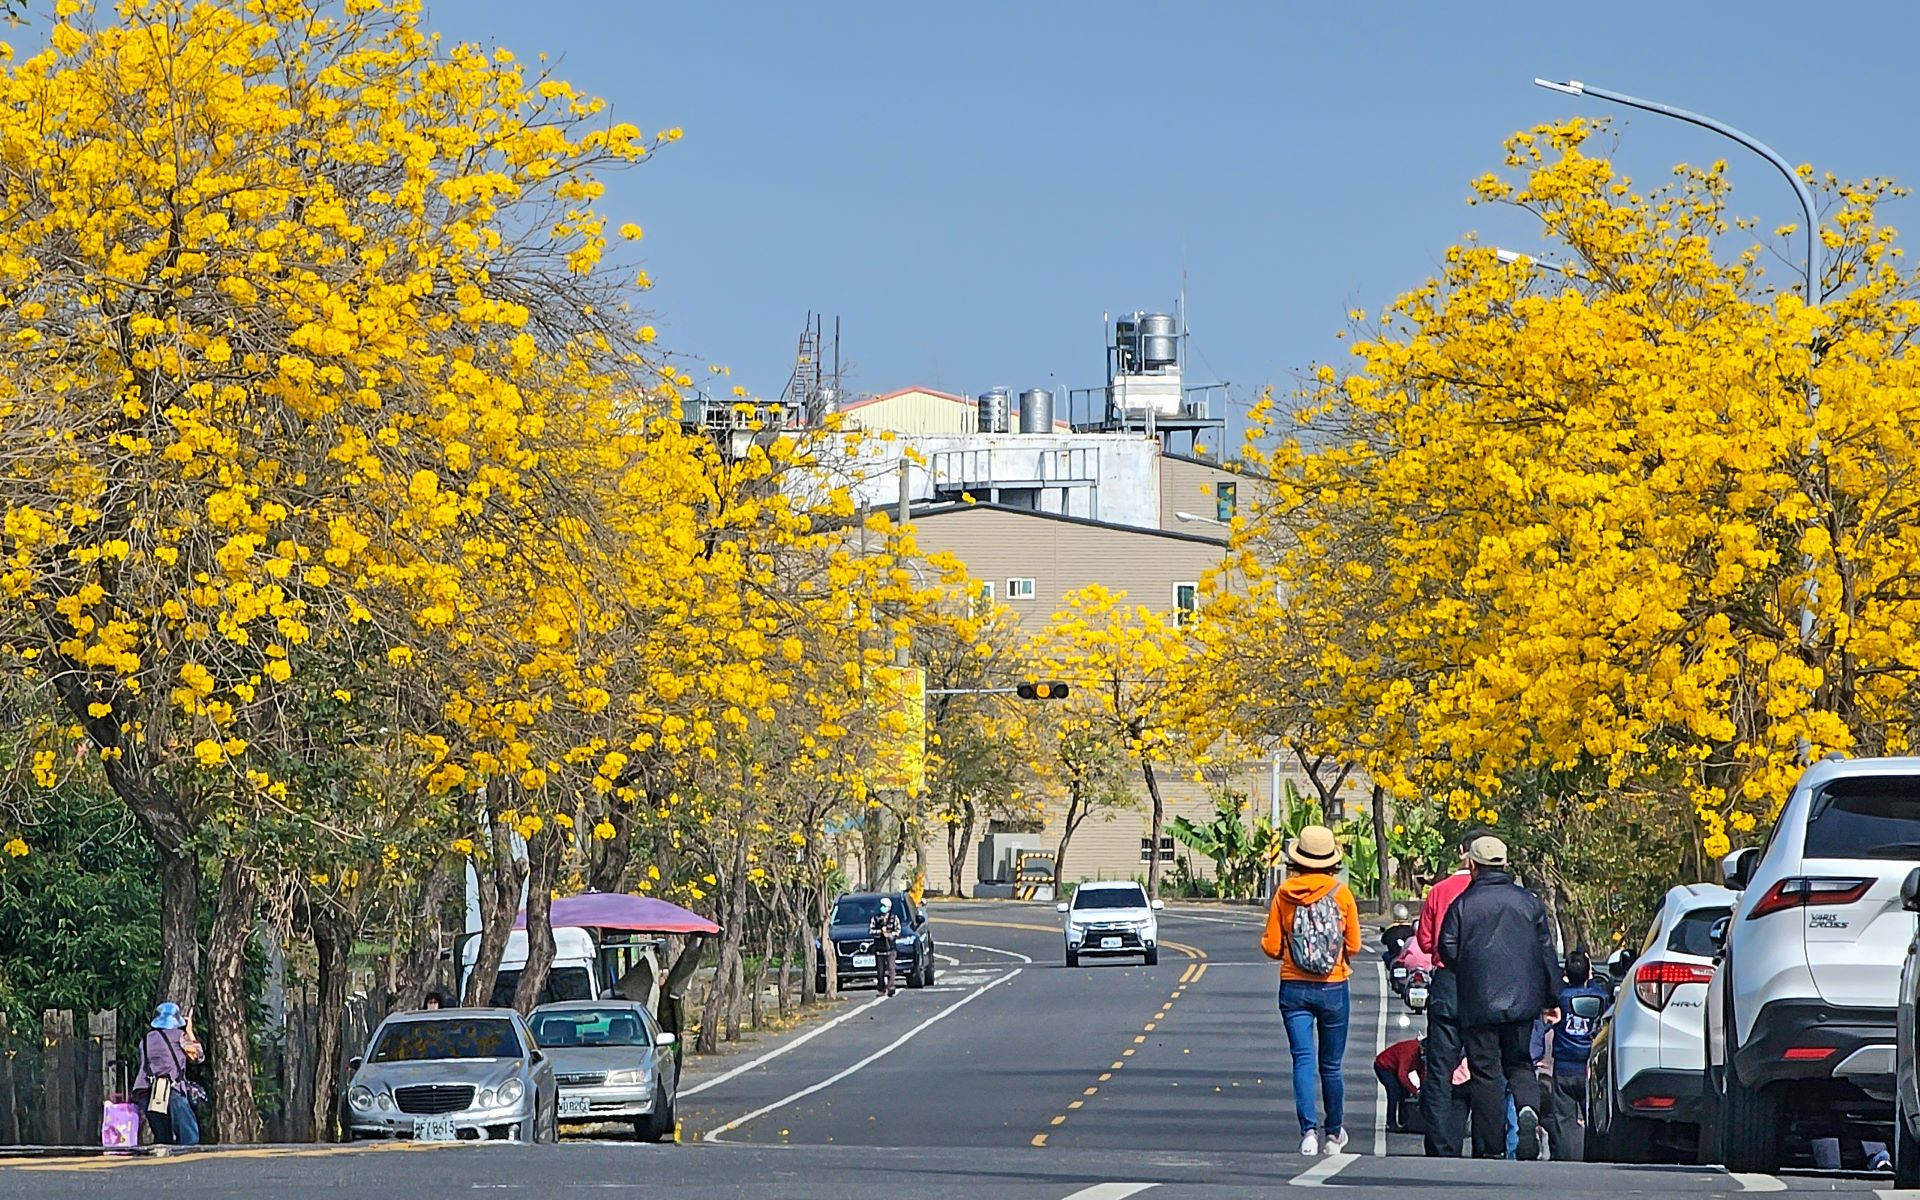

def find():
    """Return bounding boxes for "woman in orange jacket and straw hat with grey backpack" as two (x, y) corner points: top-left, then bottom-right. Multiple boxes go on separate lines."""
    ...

(1260, 826), (1361, 1154)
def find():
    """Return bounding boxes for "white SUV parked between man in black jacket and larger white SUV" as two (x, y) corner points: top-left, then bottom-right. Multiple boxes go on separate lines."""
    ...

(1586, 883), (1736, 1162)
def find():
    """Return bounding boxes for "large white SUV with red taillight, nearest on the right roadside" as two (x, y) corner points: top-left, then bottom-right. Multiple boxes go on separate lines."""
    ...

(1701, 758), (1920, 1171)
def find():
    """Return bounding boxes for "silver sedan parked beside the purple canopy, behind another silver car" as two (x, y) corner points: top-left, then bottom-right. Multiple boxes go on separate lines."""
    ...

(528, 1000), (680, 1142)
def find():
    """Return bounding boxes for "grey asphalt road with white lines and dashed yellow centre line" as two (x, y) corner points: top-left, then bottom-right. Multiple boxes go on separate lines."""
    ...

(0, 902), (1920, 1200)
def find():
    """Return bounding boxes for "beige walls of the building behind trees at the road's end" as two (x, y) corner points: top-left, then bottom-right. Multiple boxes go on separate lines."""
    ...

(914, 499), (1344, 879)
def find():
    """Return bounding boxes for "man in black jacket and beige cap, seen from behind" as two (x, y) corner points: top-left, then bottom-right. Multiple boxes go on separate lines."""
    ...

(1438, 835), (1559, 1160)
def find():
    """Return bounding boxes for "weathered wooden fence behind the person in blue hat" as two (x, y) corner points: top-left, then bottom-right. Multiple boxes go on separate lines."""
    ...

(0, 991), (386, 1146)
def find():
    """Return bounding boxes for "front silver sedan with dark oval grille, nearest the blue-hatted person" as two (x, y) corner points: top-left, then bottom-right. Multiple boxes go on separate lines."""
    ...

(340, 1008), (561, 1142)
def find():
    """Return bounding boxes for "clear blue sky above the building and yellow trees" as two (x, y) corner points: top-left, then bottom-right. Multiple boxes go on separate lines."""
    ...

(430, 0), (1920, 432)
